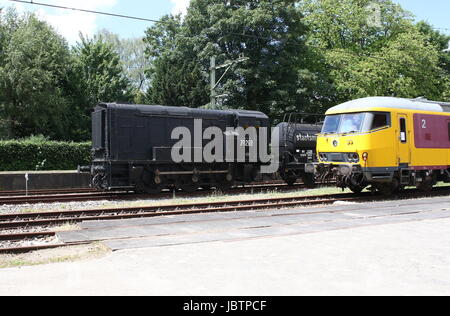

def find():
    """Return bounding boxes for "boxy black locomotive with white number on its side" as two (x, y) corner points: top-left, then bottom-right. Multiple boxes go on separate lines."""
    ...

(85, 103), (269, 193)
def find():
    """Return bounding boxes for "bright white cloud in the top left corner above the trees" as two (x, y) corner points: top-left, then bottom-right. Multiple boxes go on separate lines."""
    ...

(0, 0), (118, 44)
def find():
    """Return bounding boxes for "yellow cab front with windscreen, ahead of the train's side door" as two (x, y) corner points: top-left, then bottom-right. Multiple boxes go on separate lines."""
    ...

(317, 111), (394, 192)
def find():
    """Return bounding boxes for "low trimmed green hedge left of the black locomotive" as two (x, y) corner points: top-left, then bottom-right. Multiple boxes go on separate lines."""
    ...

(0, 137), (91, 171)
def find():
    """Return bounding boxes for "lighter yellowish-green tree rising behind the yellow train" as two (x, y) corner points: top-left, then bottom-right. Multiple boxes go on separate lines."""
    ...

(300, 0), (448, 101)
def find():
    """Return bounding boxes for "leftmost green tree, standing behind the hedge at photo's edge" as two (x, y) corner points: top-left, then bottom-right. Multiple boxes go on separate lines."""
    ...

(0, 10), (70, 139)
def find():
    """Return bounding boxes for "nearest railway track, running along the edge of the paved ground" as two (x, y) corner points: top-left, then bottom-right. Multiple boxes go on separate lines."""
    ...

(0, 187), (450, 254)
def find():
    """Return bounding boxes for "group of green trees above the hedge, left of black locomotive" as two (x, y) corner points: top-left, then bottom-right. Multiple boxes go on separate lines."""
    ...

(0, 10), (132, 141)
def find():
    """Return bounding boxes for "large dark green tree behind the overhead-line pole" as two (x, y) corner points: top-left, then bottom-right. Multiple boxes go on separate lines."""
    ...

(146, 0), (331, 117)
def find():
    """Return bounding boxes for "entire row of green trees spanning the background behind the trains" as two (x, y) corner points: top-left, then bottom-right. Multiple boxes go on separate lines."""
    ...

(0, 0), (450, 144)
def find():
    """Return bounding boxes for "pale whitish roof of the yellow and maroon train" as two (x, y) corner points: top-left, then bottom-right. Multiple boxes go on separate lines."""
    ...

(327, 97), (450, 114)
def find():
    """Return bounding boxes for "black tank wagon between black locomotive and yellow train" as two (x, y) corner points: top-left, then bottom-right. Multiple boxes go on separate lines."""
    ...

(277, 120), (322, 187)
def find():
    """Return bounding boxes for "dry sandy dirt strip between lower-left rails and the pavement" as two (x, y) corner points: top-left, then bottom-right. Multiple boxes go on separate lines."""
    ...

(0, 243), (111, 269)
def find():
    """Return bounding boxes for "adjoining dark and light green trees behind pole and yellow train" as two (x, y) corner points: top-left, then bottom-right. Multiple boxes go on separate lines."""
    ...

(145, 0), (450, 117)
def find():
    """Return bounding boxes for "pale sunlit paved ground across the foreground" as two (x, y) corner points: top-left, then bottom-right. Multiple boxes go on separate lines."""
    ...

(0, 198), (450, 295)
